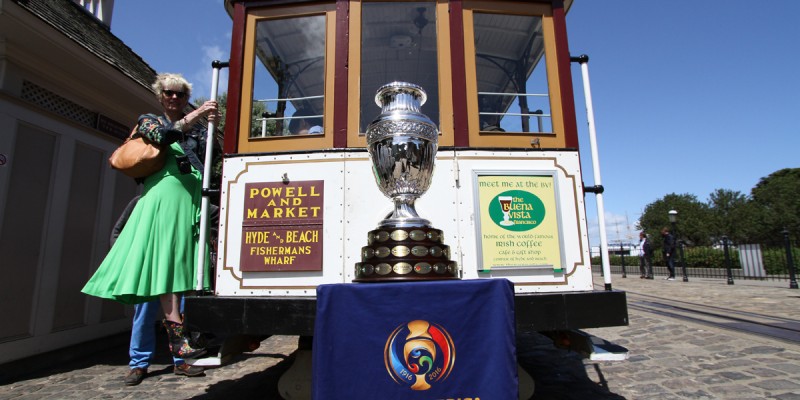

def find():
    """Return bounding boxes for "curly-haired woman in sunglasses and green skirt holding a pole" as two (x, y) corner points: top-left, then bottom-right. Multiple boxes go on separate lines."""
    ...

(82, 74), (217, 358)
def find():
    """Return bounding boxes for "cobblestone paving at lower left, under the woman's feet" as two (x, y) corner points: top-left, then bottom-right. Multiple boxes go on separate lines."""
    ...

(0, 336), (297, 400)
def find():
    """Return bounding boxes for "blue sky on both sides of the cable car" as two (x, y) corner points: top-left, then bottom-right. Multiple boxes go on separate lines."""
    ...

(111, 0), (800, 245)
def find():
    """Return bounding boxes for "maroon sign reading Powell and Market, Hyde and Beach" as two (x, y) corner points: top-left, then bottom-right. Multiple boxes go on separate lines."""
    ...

(240, 180), (325, 272)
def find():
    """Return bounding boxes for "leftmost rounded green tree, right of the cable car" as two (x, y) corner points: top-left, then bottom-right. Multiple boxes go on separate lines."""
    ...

(637, 193), (712, 247)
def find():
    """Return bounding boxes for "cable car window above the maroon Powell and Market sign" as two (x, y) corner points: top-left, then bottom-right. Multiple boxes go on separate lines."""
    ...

(250, 15), (325, 138)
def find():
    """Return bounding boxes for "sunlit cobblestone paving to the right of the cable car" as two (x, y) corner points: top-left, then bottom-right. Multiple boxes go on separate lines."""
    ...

(568, 274), (800, 400)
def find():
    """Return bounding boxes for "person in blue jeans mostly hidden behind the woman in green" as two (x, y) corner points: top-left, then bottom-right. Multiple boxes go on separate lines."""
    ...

(110, 196), (205, 386)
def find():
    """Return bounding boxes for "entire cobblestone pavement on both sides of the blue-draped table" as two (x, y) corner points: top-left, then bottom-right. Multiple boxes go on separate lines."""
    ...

(0, 275), (800, 400)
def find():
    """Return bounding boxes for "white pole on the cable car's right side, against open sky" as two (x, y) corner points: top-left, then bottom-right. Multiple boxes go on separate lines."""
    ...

(573, 55), (611, 290)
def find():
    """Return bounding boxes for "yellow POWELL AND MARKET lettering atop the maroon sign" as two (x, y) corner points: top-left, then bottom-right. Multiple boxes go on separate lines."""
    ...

(246, 186), (321, 219)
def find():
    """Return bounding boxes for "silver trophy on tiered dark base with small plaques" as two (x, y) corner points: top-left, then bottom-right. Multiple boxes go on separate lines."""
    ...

(354, 82), (457, 282)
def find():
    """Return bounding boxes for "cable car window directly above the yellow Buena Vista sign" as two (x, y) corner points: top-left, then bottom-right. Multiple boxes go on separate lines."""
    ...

(474, 12), (553, 133)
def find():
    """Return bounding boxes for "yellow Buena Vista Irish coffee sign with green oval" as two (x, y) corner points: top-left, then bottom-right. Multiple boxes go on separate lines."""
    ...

(476, 175), (562, 272)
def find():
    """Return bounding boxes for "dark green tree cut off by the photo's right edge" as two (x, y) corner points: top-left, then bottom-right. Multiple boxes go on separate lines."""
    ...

(750, 168), (800, 243)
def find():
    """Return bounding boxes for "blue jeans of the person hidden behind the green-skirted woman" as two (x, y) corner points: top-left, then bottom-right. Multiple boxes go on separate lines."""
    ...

(128, 300), (183, 369)
